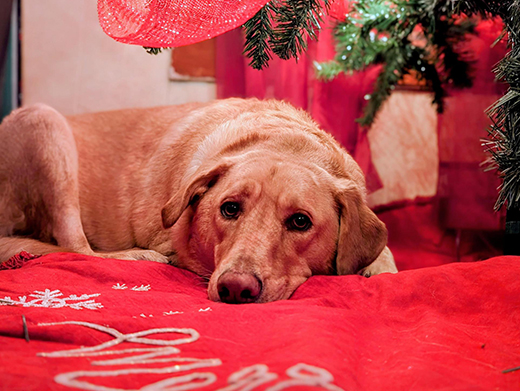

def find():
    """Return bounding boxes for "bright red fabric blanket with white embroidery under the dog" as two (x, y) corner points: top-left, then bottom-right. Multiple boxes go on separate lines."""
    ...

(0, 254), (520, 391)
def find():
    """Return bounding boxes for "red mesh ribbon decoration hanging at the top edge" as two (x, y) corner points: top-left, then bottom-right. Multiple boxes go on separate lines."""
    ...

(98, 0), (269, 48)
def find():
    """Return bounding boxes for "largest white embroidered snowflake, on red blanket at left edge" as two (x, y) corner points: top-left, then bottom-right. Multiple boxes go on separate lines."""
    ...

(0, 289), (103, 310)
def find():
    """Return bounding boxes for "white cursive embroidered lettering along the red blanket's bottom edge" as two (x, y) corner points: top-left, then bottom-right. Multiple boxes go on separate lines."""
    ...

(38, 321), (344, 391)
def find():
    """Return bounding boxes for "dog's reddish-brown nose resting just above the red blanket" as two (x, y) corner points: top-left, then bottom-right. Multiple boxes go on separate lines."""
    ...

(217, 272), (262, 304)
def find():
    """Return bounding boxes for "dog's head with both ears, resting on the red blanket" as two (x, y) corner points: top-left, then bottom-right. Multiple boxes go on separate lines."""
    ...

(162, 153), (387, 303)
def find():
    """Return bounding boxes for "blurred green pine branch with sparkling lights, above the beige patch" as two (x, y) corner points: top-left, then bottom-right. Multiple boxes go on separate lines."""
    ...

(316, 0), (475, 126)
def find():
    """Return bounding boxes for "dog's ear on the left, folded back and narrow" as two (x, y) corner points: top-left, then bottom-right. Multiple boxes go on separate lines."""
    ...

(161, 161), (231, 228)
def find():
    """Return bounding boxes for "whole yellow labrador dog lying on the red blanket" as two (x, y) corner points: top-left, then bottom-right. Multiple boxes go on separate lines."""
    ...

(0, 99), (397, 303)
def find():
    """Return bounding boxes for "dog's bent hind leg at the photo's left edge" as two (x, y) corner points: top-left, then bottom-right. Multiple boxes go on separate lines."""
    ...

(0, 105), (93, 261)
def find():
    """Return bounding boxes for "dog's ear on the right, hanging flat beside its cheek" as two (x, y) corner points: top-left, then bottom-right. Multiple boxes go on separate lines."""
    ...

(336, 181), (387, 275)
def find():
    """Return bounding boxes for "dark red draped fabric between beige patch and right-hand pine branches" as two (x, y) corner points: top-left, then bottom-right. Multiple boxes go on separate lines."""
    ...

(439, 20), (506, 230)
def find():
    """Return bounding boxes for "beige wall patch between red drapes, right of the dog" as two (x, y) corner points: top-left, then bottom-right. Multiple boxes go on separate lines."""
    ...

(368, 90), (439, 207)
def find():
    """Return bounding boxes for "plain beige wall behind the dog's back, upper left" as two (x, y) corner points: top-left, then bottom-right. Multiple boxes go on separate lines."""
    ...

(22, 0), (216, 114)
